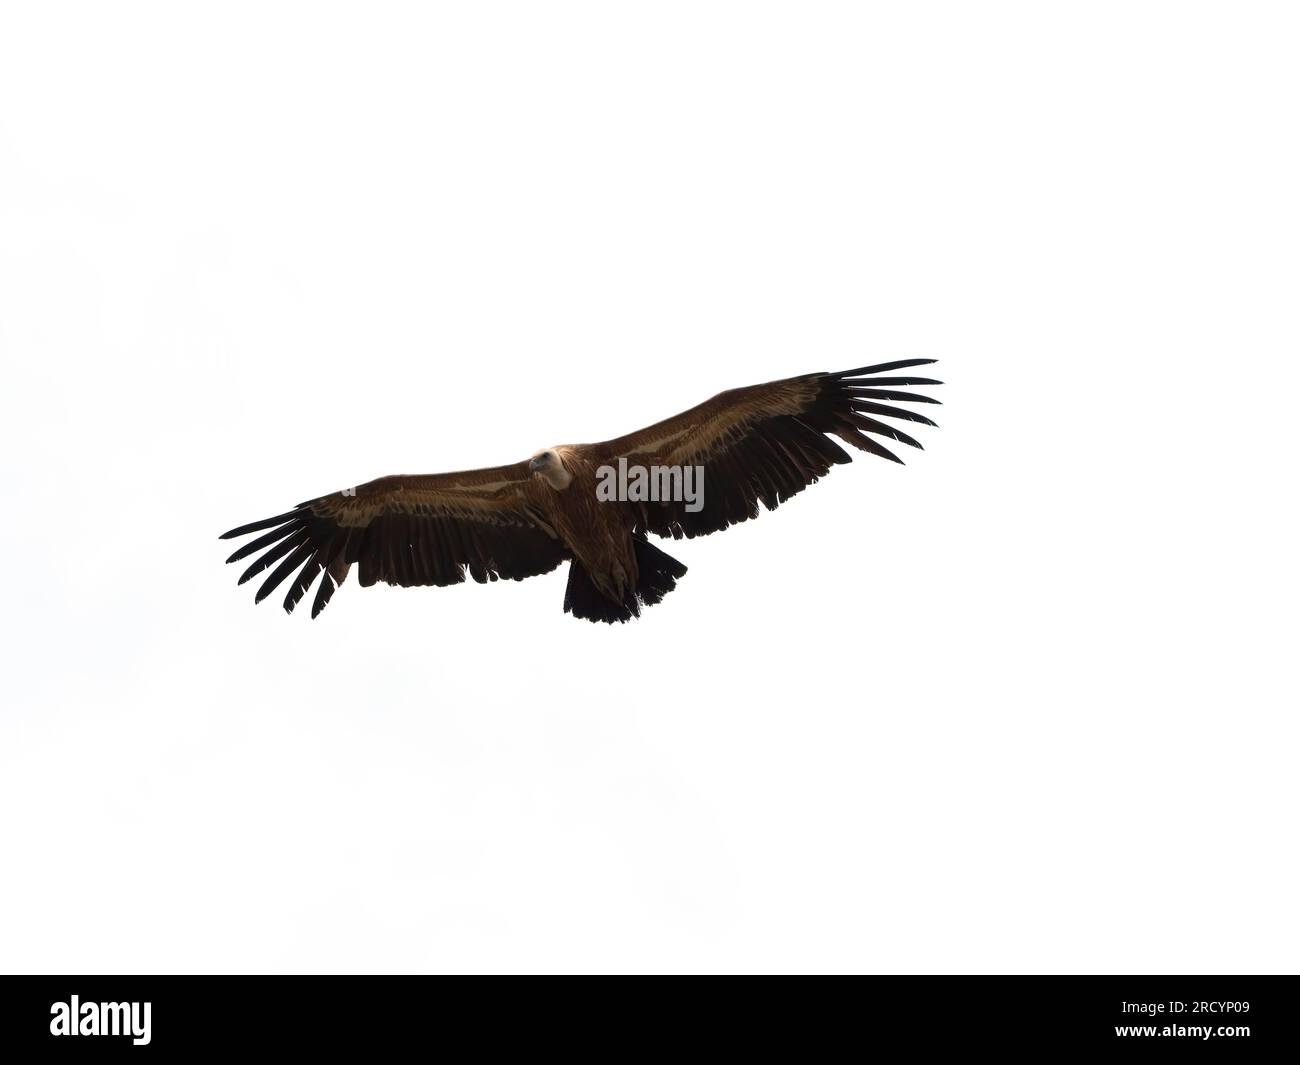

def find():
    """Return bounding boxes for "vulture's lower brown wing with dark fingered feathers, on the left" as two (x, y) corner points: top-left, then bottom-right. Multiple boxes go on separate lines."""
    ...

(221, 463), (569, 618)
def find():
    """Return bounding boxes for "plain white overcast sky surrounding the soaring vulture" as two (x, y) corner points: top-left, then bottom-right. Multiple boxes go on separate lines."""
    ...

(0, 3), (1300, 973)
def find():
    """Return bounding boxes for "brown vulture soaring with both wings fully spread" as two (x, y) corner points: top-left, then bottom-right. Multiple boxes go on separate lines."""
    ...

(221, 359), (940, 622)
